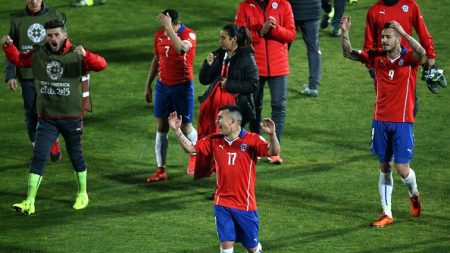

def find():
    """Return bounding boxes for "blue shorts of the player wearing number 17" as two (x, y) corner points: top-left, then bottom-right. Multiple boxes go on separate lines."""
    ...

(214, 205), (259, 249)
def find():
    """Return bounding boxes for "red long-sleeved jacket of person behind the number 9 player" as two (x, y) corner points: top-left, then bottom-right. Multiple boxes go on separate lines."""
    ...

(364, 0), (436, 59)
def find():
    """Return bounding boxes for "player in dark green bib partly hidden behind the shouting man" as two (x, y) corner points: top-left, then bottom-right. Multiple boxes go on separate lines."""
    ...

(5, 0), (65, 162)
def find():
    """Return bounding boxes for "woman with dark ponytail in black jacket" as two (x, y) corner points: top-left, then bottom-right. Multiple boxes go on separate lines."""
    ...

(199, 24), (259, 126)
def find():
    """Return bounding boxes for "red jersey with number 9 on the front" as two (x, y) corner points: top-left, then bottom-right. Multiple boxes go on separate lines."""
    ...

(361, 47), (421, 122)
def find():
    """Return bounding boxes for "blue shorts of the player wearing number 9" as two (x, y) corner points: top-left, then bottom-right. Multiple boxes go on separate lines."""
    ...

(372, 120), (414, 164)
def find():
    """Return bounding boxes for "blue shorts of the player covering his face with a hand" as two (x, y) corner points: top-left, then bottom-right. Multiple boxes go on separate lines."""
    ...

(153, 80), (194, 123)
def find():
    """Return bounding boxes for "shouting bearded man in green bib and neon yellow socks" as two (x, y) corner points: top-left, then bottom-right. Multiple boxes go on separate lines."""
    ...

(1, 20), (106, 215)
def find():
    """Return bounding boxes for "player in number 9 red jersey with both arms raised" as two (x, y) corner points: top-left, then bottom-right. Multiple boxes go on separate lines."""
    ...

(341, 17), (425, 227)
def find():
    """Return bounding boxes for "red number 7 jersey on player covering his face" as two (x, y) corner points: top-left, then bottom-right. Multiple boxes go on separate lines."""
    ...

(154, 24), (196, 86)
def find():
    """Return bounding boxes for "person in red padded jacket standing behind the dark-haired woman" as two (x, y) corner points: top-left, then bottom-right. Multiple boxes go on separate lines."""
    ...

(235, 0), (296, 164)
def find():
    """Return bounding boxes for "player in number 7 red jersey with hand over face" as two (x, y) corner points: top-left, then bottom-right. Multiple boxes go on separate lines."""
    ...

(144, 9), (197, 182)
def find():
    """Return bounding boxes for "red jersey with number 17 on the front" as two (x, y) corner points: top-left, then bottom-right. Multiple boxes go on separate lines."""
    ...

(195, 129), (269, 211)
